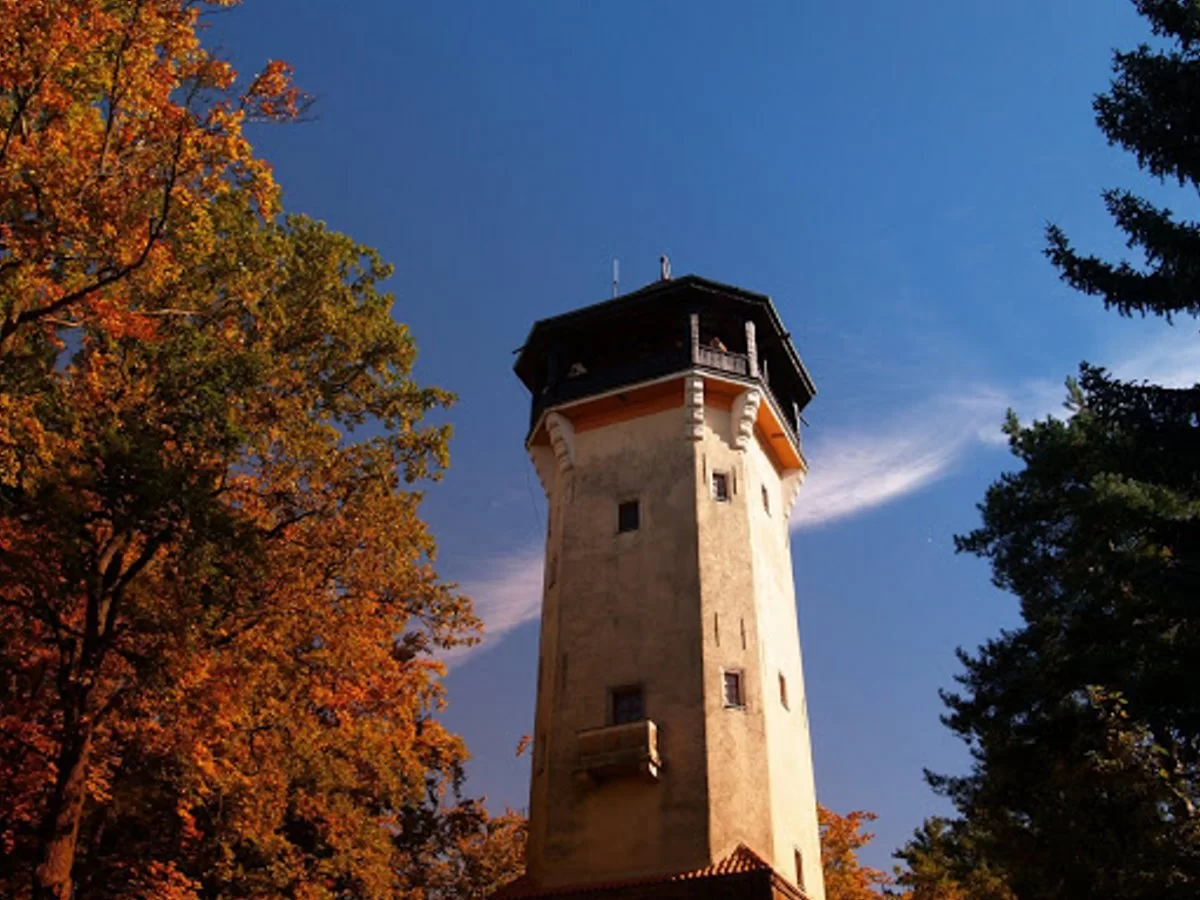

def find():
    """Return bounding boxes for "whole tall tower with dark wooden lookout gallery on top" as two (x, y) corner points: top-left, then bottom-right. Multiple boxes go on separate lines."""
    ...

(504, 276), (824, 900)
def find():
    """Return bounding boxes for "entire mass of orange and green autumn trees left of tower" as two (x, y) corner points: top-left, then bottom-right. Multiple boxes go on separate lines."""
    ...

(0, 0), (515, 900)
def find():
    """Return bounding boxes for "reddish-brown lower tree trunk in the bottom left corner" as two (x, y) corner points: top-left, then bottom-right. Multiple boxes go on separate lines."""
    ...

(34, 725), (91, 900)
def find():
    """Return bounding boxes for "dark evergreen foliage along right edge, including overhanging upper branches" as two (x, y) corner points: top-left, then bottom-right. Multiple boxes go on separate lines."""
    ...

(901, 0), (1200, 900)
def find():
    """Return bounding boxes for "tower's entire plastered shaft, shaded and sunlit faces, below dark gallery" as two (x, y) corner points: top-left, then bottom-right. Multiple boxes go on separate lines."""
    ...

(529, 378), (823, 900)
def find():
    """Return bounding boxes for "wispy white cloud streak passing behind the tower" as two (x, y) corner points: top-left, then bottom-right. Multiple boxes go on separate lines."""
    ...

(448, 328), (1200, 665)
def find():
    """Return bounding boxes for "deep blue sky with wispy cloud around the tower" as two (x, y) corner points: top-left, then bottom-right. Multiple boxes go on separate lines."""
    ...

(210, 0), (1200, 865)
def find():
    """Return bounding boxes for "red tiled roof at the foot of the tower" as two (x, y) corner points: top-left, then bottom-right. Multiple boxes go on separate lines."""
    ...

(492, 844), (808, 900)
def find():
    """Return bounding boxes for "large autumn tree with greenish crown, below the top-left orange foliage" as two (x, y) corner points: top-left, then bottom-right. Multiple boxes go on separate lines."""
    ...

(0, 209), (475, 898)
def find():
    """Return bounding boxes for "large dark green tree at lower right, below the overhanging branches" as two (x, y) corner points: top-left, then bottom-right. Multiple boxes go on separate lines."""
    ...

(908, 366), (1200, 900)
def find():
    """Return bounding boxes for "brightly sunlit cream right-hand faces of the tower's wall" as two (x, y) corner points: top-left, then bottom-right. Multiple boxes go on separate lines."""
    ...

(696, 404), (823, 900)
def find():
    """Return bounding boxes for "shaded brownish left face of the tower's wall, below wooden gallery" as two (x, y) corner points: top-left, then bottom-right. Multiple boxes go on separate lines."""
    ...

(529, 408), (709, 886)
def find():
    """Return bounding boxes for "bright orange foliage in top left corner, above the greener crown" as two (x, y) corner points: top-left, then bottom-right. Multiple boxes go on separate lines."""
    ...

(0, 0), (305, 355)
